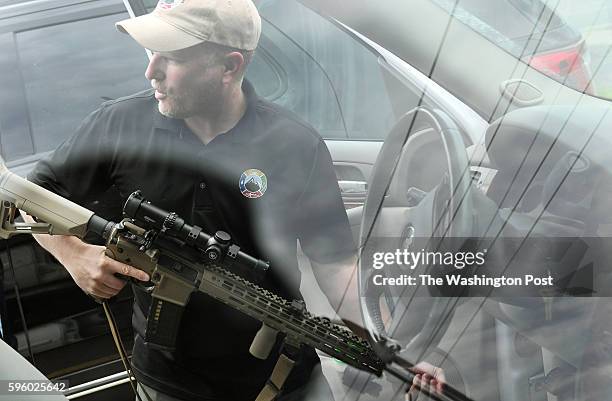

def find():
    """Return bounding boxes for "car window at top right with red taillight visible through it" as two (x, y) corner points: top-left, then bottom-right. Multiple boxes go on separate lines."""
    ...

(432, 0), (612, 99)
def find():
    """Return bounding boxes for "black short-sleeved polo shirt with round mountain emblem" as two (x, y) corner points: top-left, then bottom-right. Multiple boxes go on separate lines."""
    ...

(28, 82), (354, 400)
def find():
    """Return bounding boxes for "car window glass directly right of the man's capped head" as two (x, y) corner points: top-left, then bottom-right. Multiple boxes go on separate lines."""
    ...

(259, 0), (394, 139)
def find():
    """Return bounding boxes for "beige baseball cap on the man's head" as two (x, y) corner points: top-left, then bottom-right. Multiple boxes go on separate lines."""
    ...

(115, 0), (261, 52)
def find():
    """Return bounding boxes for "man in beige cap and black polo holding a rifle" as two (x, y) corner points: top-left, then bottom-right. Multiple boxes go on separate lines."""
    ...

(28, 0), (354, 401)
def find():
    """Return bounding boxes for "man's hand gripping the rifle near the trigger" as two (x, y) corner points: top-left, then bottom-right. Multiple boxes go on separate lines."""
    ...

(56, 238), (149, 299)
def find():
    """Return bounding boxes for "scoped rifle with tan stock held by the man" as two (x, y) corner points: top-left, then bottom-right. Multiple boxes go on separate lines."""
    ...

(0, 159), (471, 401)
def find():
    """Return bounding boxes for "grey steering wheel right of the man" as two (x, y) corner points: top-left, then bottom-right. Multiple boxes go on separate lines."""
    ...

(359, 107), (473, 358)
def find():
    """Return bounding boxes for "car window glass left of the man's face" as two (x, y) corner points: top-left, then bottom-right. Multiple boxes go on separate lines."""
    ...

(12, 14), (148, 159)
